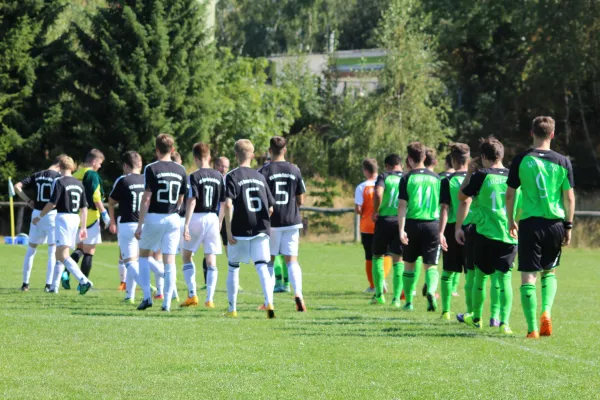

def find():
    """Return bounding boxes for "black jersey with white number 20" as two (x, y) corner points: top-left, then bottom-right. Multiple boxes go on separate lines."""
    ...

(144, 161), (187, 214)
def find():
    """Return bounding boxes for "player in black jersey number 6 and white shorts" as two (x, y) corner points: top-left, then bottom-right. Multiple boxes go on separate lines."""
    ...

(225, 139), (275, 318)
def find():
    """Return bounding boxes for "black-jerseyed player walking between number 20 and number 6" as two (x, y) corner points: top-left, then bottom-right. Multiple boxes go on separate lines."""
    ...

(181, 143), (225, 308)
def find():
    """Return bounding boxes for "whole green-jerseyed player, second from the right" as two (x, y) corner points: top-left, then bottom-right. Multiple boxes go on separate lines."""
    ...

(455, 136), (517, 334)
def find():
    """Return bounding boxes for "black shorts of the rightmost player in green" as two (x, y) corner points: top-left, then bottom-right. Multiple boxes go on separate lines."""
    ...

(519, 218), (566, 272)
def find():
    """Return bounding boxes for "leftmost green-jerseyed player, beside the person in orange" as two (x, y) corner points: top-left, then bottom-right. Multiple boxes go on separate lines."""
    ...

(371, 154), (404, 307)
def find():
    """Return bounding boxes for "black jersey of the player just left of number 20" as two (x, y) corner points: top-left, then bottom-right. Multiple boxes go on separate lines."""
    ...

(109, 174), (144, 224)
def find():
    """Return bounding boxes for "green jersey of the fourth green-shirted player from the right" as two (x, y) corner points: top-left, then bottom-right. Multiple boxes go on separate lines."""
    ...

(400, 168), (440, 221)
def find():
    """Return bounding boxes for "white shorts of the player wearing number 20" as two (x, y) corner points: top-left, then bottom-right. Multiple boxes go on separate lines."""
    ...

(140, 213), (181, 254)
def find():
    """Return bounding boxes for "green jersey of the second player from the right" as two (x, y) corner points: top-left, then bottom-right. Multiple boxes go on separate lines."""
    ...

(463, 168), (520, 244)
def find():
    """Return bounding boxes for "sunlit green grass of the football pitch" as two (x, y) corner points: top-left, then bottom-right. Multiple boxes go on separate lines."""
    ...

(0, 244), (600, 399)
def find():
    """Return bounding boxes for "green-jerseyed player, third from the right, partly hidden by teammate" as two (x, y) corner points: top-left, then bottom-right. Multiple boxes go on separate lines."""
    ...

(439, 143), (471, 320)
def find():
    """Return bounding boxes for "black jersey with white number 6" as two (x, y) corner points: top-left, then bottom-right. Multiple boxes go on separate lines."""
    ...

(225, 167), (275, 237)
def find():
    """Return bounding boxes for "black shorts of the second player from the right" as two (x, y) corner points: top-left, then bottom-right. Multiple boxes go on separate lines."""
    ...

(474, 233), (517, 275)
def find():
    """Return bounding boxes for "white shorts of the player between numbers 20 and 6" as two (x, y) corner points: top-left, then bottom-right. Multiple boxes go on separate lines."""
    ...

(183, 213), (222, 254)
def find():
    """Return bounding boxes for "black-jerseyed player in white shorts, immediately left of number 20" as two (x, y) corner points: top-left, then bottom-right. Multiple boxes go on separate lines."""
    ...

(108, 151), (144, 303)
